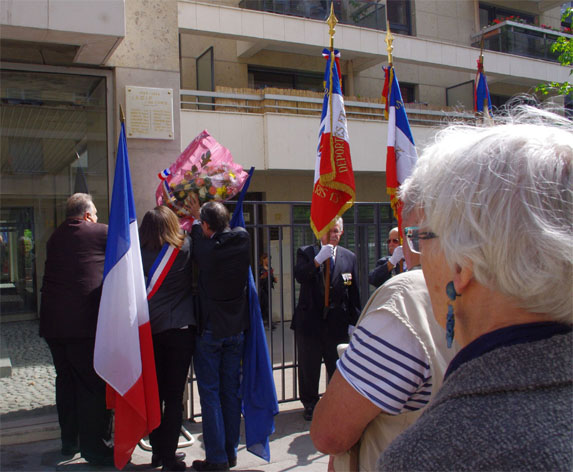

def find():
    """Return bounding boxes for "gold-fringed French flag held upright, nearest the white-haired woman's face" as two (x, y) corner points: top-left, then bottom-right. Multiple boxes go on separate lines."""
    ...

(382, 66), (418, 232)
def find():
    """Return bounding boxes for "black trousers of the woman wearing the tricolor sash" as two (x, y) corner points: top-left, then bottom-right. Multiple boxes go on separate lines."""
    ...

(149, 327), (195, 464)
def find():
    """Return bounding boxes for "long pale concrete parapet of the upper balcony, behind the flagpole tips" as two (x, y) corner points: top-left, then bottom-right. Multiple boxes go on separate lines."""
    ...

(177, 0), (568, 86)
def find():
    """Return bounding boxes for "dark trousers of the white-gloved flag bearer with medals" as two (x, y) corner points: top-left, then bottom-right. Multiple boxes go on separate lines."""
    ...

(296, 329), (348, 408)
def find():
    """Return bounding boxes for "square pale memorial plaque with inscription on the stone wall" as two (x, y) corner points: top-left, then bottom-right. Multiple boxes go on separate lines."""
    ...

(125, 85), (174, 139)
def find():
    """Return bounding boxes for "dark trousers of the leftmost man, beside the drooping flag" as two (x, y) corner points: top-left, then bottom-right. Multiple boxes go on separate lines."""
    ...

(46, 338), (112, 459)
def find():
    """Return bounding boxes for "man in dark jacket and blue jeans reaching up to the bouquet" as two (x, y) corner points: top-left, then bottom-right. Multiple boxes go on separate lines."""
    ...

(191, 196), (250, 470)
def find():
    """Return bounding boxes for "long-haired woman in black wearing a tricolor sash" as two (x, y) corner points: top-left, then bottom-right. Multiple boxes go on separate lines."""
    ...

(139, 206), (196, 470)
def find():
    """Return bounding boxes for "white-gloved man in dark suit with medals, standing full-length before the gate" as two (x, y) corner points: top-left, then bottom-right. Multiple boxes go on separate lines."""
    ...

(291, 218), (361, 421)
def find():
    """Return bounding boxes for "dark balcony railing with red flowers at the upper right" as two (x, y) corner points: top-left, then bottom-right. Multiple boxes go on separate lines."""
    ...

(472, 21), (573, 62)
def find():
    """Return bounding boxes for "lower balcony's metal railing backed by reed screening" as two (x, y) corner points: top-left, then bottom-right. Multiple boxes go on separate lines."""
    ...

(180, 87), (476, 126)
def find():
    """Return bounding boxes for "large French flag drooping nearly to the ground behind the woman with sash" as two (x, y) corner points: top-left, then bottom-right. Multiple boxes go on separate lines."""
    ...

(94, 123), (161, 469)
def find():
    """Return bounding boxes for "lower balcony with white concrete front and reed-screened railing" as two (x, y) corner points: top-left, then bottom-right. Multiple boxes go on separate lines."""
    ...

(181, 90), (475, 172)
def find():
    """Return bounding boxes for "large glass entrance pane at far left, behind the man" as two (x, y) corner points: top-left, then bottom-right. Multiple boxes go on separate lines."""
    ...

(0, 64), (111, 422)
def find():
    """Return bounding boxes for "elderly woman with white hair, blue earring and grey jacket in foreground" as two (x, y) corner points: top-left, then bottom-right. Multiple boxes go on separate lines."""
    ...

(377, 108), (573, 471)
